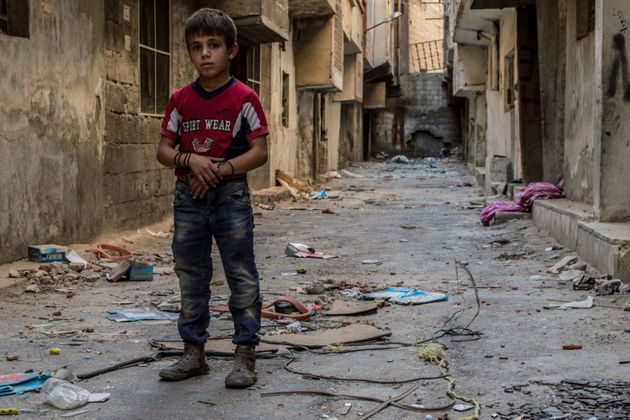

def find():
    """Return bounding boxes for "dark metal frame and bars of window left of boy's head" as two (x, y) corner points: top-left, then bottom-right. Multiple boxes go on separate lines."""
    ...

(137, 0), (173, 117)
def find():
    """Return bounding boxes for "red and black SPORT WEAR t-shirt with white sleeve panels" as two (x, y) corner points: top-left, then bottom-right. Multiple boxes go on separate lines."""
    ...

(160, 77), (269, 171)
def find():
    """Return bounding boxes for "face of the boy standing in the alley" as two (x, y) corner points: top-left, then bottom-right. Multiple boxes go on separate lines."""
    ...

(188, 34), (238, 80)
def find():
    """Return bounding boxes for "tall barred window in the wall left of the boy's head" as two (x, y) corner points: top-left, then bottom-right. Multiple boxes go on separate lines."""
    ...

(140, 0), (171, 114)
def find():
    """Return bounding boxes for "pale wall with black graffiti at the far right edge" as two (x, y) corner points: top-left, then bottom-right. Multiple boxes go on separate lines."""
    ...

(594, 0), (630, 222)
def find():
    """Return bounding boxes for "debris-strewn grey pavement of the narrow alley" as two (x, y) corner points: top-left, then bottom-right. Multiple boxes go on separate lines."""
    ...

(0, 158), (630, 419)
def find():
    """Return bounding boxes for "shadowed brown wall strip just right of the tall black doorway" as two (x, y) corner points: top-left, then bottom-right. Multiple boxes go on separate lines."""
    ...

(536, 0), (567, 183)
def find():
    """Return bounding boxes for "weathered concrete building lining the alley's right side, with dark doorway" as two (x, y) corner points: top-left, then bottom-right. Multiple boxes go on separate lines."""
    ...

(446, 0), (630, 281)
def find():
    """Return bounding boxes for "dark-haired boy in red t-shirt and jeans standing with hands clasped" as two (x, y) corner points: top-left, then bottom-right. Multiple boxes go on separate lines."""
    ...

(157, 8), (268, 388)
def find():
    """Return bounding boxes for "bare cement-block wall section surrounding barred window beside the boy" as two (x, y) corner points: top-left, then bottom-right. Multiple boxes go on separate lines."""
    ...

(103, 0), (195, 231)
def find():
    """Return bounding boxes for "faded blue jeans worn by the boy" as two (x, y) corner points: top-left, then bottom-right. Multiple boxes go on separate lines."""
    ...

(173, 180), (262, 345)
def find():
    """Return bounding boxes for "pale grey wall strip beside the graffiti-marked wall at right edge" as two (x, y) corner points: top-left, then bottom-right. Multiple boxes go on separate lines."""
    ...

(563, 0), (596, 204)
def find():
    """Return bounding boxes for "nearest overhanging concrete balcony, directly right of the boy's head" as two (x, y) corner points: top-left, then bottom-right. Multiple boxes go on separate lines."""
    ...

(200, 0), (289, 44)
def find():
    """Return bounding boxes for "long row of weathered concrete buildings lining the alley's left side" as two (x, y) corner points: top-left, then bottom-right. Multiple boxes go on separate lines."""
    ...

(0, 0), (370, 262)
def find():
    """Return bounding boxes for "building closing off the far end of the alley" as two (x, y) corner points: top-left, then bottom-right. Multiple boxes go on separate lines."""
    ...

(364, 0), (460, 157)
